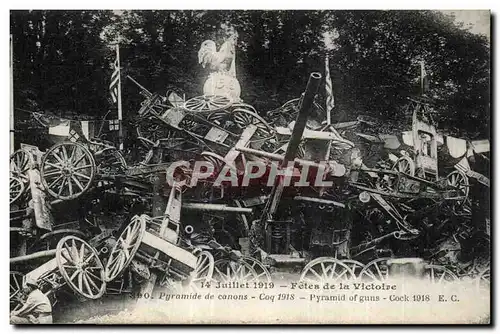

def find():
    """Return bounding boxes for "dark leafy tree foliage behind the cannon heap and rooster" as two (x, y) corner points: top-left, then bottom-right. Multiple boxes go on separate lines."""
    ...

(11, 10), (490, 138)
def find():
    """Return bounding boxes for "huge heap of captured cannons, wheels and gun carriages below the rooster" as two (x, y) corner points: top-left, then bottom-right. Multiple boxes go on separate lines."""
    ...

(10, 73), (489, 308)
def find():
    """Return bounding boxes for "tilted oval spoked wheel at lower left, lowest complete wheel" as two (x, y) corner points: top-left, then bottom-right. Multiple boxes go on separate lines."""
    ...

(56, 236), (106, 299)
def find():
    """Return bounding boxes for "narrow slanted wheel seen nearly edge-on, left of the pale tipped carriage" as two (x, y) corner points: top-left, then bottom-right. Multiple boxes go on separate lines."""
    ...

(105, 216), (146, 282)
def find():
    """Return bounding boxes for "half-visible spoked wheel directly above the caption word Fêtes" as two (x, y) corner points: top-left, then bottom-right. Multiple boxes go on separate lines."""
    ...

(300, 257), (354, 285)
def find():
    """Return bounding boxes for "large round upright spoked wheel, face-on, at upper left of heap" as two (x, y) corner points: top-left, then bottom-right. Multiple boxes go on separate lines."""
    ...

(40, 143), (96, 200)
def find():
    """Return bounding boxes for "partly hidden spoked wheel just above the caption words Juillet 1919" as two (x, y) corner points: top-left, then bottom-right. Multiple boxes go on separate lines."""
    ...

(213, 259), (259, 283)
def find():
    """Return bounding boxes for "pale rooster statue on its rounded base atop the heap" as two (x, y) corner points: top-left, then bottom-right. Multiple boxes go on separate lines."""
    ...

(198, 34), (241, 102)
